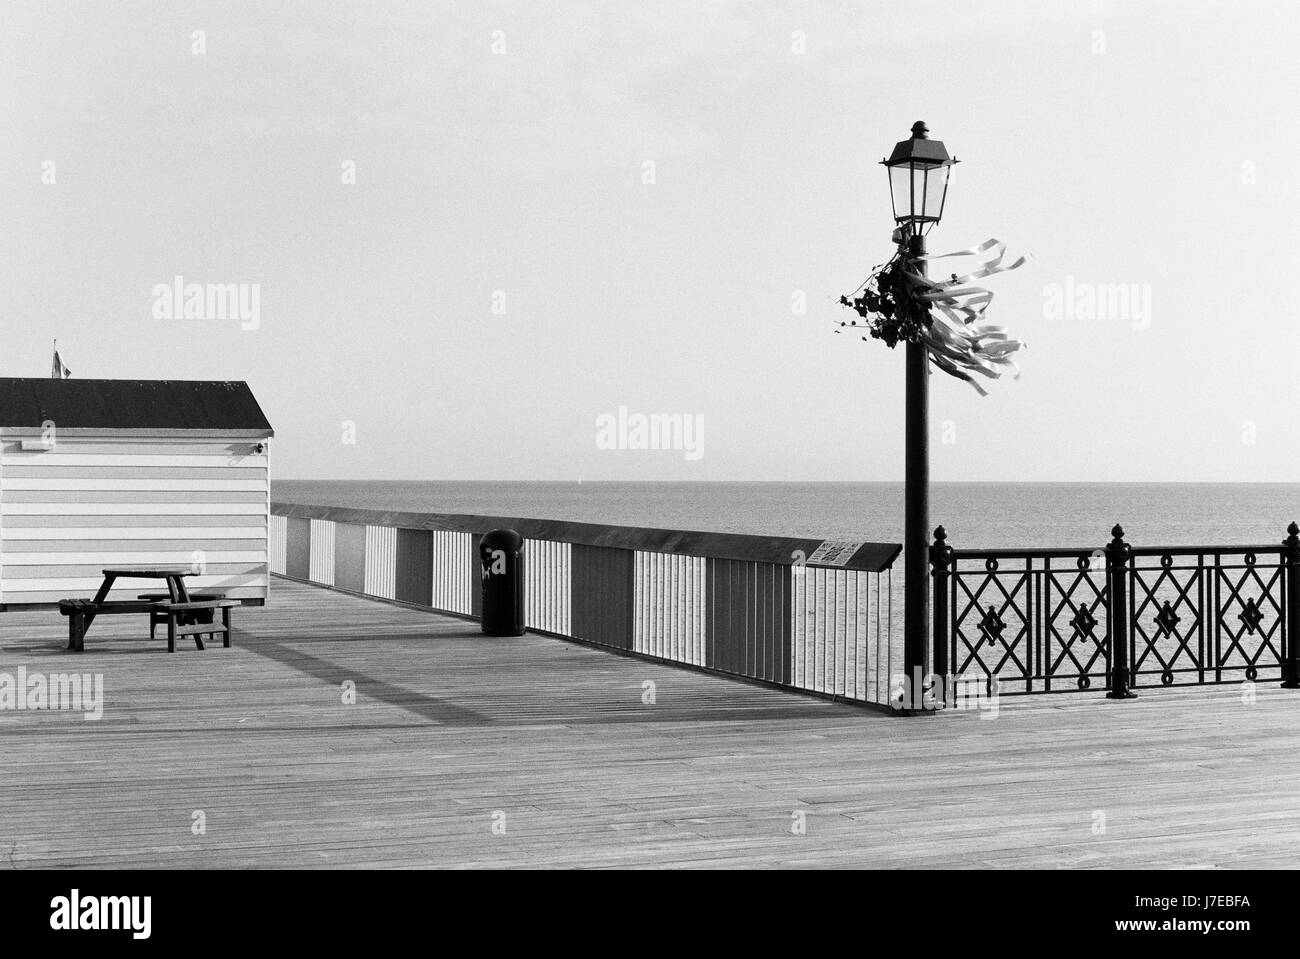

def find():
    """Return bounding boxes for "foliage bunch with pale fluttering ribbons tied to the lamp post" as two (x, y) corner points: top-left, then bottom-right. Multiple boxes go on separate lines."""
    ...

(840, 238), (1032, 396)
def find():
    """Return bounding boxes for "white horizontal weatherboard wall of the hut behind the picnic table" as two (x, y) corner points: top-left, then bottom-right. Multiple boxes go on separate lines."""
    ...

(0, 434), (269, 604)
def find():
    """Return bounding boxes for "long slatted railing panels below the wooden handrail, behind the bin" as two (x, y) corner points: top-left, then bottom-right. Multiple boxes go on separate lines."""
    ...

(270, 504), (902, 704)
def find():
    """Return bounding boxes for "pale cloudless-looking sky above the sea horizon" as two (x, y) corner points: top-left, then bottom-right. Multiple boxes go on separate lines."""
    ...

(0, 0), (1300, 481)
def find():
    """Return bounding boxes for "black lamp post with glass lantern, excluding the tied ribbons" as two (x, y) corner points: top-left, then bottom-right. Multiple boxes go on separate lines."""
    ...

(880, 120), (957, 712)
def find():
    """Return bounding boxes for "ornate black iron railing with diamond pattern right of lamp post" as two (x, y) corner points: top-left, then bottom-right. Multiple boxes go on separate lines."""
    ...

(931, 522), (1300, 699)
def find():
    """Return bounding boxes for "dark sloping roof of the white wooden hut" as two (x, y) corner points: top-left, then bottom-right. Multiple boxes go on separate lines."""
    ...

(0, 377), (274, 437)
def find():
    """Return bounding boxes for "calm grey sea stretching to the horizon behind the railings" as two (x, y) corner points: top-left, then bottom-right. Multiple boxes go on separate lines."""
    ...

(272, 480), (1300, 548)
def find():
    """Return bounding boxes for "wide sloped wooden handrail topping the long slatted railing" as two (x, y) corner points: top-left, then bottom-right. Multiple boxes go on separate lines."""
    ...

(270, 502), (902, 573)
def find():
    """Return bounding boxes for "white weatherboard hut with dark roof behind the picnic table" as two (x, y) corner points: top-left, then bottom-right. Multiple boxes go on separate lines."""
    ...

(0, 378), (273, 609)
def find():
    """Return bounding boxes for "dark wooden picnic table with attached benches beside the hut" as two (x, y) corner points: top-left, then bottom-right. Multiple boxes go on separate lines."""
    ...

(59, 569), (241, 652)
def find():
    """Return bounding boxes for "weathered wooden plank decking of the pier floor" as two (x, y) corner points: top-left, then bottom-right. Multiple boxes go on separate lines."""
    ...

(0, 581), (1300, 868)
